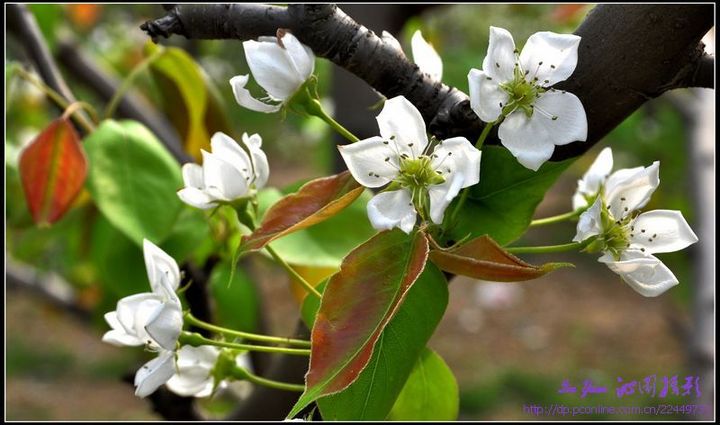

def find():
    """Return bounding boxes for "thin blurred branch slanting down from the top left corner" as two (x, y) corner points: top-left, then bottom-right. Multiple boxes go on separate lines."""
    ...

(5, 4), (89, 133)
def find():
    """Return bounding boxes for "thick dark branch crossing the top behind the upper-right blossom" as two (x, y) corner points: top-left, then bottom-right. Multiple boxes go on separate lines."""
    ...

(142, 4), (714, 160)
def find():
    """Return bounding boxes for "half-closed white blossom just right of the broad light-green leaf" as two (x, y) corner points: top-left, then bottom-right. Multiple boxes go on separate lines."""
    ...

(178, 132), (270, 209)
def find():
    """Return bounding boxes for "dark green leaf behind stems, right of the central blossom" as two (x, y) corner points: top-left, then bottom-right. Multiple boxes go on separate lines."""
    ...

(446, 146), (574, 245)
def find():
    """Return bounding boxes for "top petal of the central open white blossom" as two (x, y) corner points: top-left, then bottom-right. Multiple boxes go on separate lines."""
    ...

(377, 96), (428, 158)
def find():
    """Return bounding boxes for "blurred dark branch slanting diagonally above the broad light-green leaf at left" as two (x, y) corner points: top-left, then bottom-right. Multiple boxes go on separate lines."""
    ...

(57, 41), (192, 164)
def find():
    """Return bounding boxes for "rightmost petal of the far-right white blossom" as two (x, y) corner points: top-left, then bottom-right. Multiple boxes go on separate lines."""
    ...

(630, 210), (698, 254)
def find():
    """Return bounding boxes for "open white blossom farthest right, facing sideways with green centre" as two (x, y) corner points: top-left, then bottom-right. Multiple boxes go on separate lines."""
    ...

(573, 162), (698, 297)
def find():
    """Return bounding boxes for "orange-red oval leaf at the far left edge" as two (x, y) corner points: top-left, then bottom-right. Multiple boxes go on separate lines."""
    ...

(19, 118), (87, 224)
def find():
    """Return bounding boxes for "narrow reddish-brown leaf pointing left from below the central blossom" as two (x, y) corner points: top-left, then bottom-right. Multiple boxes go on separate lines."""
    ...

(239, 171), (364, 252)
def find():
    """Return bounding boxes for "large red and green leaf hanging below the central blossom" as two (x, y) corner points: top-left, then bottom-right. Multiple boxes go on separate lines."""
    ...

(289, 229), (429, 417)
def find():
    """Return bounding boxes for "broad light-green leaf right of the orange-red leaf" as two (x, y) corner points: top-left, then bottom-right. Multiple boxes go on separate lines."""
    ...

(85, 120), (182, 246)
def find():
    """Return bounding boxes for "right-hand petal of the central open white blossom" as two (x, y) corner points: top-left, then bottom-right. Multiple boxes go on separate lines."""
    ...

(430, 137), (482, 188)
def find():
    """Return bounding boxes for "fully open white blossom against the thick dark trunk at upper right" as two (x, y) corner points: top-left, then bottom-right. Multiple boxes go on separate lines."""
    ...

(468, 27), (587, 171)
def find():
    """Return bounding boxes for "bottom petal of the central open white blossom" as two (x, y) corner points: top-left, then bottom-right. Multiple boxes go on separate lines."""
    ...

(367, 189), (416, 233)
